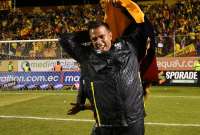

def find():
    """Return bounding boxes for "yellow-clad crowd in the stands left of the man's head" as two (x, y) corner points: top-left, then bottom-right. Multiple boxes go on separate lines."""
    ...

(0, 5), (103, 59)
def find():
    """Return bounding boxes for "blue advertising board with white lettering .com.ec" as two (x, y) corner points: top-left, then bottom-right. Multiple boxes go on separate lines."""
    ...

(0, 71), (80, 87)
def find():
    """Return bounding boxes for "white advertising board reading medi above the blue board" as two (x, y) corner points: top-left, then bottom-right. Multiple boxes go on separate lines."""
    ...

(18, 59), (79, 72)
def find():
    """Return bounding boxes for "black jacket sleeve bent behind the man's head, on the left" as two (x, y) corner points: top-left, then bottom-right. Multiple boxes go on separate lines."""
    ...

(59, 31), (90, 62)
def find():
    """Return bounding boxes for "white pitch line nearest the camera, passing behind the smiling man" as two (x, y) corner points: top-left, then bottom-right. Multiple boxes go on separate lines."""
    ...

(0, 115), (200, 127)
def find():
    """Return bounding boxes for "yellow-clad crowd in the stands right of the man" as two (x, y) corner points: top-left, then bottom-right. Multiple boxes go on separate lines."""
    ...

(143, 0), (200, 56)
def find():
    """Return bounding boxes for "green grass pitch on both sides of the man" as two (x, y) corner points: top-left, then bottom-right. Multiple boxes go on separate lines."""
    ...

(0, 87), (200, 135)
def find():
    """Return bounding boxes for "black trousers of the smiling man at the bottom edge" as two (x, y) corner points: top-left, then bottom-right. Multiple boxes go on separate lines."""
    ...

(91, 119), (144, 135)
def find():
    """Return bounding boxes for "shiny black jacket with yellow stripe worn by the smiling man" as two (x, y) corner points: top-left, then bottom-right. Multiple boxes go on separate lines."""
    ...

(60, 20), (147, 127)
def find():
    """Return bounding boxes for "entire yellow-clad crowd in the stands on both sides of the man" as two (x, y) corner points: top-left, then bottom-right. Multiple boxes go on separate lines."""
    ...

(0, 0), (200, 58)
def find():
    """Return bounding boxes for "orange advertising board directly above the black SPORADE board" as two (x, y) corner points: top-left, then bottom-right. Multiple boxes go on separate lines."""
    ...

(156, 57), (198, 71)
